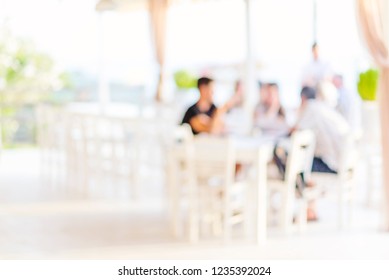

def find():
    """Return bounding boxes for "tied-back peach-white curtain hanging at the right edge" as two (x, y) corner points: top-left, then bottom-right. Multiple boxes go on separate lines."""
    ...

(356, 0), (389, 230)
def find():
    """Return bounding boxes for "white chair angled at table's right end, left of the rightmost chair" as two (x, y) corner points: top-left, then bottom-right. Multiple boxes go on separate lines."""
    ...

(268, 130), (315, 232)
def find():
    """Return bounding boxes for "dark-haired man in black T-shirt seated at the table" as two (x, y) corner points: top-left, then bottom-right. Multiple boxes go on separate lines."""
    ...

(182, 77), (236, 135)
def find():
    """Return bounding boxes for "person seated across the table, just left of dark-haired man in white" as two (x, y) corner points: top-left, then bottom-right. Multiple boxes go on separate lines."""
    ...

(254, 83), (289, 135)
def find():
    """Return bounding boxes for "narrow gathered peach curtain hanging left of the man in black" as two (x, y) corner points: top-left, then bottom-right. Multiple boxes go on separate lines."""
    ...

(148, 0), (169, 101)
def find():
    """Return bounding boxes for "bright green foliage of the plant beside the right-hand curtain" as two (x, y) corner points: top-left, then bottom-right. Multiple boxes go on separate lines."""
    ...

(358, 69), (379, 101)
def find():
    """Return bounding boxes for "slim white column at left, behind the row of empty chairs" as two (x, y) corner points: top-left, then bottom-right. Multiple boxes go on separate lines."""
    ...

(97, 12), (110, 114)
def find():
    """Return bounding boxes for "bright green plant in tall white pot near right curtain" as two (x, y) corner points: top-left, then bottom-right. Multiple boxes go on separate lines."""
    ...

(358, 68), (380, 143)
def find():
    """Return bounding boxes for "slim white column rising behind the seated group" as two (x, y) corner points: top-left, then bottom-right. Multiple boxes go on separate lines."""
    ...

(244, 0), (258, 126)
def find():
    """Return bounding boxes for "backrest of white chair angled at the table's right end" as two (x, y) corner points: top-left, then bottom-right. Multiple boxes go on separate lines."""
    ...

(285, 130), (315, 188)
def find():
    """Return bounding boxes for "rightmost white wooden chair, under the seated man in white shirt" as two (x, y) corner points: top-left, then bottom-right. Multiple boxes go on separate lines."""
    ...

(312, 133), (359, 228)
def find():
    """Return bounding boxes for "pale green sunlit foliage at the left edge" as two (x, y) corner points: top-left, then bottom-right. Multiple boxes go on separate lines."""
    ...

(0, 26), (71, 147)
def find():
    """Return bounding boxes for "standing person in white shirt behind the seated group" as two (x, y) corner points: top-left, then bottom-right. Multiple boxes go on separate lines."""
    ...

(302, 43), (332, 87)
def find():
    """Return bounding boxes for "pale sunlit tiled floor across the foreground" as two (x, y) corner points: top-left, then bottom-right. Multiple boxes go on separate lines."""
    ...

(0, 150), (389, 259)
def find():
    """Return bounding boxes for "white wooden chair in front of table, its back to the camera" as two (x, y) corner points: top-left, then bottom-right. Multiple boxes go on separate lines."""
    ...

(190, 137), (247, 241)
